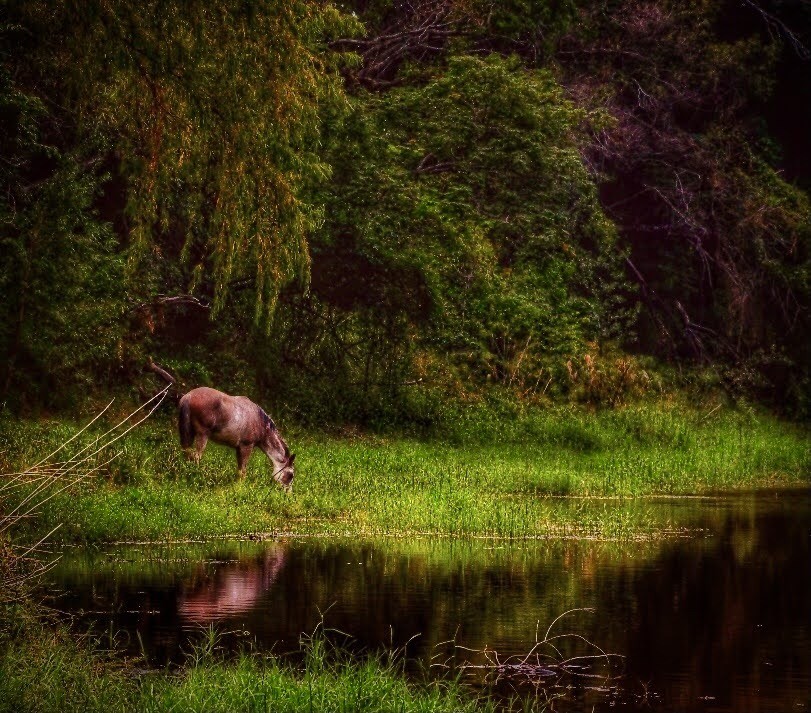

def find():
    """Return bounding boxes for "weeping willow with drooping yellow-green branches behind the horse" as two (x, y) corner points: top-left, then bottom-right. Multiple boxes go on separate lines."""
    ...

(5, 0), (357, 323)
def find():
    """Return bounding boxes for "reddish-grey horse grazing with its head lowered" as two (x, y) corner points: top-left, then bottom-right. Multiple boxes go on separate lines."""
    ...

(178, 386), (296, 490)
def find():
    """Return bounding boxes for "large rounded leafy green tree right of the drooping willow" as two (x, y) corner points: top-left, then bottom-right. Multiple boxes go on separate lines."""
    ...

(274, 55), (627, 417)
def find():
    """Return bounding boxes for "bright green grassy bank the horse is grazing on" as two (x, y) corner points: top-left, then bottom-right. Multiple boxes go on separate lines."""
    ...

(0, 405), (809, 542)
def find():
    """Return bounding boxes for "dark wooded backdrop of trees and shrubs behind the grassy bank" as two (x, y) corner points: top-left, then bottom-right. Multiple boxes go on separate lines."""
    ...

(0, 0), (811, 425)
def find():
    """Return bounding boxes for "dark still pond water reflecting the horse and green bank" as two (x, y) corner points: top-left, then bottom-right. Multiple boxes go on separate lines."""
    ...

(48, 491), (811, 711)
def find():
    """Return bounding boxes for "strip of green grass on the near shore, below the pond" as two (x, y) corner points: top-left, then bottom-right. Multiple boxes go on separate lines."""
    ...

(0, 623), (512, 713)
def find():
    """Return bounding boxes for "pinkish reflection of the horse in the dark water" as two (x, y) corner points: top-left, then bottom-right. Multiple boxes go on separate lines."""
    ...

(177, 545), (285, 625)
